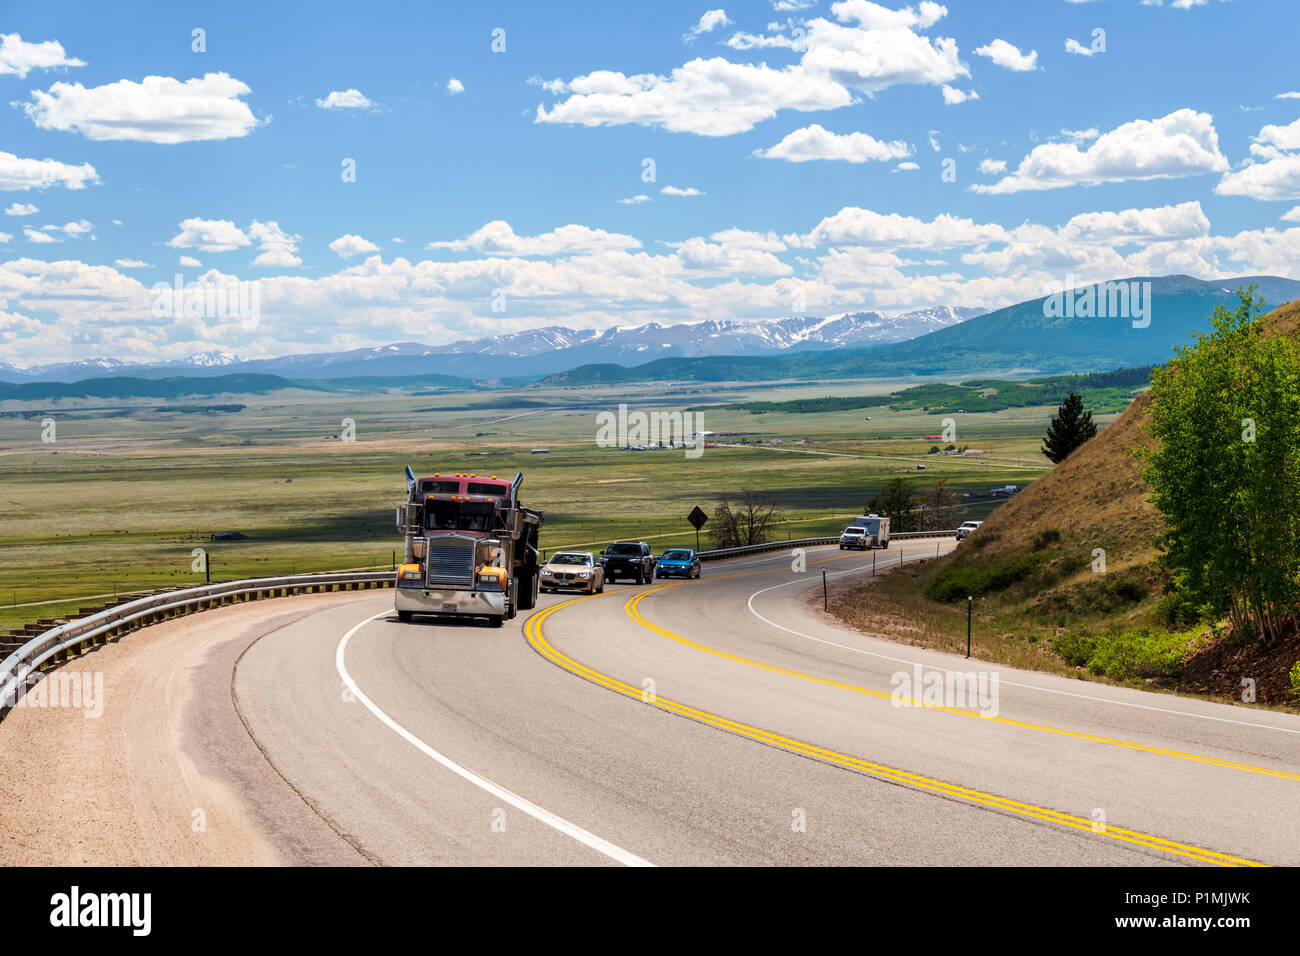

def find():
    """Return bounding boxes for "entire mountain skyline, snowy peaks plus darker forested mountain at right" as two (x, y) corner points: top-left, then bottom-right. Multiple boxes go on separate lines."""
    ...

(0, 276), (1300, 401)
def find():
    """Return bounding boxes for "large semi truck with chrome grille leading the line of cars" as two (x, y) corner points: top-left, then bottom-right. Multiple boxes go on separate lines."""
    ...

(394, 466), (542, 627)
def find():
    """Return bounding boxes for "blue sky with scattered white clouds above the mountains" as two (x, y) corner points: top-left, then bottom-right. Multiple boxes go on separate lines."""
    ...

(0, 0), (1300, 365)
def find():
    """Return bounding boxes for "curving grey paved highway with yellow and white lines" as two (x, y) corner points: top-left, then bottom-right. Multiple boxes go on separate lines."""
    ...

(0, 541), (1300, 865)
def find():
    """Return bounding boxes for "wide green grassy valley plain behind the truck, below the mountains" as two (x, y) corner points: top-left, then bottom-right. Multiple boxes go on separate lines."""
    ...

(0, 381), (1123, 630)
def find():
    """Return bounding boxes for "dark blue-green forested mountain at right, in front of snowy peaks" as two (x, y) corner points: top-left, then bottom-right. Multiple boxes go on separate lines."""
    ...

(543, 276), (1300, 385)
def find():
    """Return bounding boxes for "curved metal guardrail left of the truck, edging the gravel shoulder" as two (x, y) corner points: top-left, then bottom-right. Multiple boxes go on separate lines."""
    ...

(0, 571), (395, 715)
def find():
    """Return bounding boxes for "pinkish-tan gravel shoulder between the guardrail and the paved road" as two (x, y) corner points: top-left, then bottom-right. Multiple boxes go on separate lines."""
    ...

(0, 596), (367, 866)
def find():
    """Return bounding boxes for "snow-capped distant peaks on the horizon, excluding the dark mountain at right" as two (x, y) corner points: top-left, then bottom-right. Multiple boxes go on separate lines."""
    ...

(0, 306), (985, 382)
